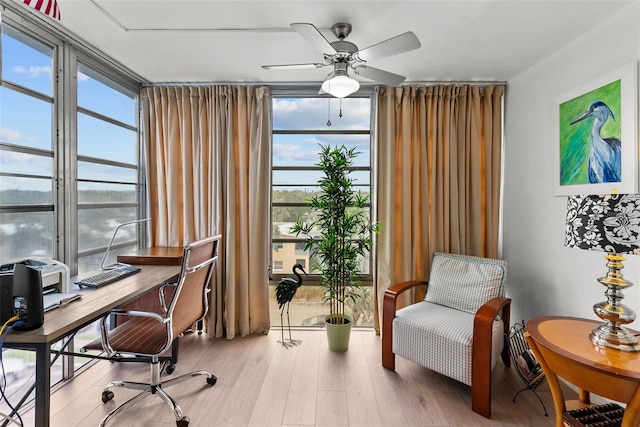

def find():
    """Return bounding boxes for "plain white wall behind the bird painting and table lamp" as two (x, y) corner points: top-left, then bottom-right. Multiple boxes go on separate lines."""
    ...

(502, 2), (640, 329)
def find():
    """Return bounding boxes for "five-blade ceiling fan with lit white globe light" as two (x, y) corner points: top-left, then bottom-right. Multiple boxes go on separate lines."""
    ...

(262, 22), (420, 98)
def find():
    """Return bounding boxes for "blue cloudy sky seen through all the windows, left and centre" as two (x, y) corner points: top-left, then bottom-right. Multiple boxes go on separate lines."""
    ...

(0, 27), (371, 195)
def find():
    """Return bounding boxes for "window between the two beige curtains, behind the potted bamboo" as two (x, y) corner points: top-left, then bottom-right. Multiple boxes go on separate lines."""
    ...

(271, 96), (373, 326)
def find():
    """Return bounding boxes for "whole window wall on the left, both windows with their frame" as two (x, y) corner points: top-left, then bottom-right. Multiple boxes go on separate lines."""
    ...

(0, 5), (144, 413)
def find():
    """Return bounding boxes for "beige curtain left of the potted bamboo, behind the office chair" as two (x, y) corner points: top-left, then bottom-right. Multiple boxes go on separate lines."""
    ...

(141, 86), (271, 338)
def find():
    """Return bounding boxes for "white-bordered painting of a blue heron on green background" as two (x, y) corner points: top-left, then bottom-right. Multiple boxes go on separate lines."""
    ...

(554, 62), (638, 196)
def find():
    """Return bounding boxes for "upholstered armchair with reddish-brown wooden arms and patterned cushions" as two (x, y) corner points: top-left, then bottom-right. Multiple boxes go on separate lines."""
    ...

(382, 253), (511, 418)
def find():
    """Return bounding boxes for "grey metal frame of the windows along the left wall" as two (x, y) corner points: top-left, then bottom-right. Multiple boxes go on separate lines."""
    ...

(0, 2), (148, 388)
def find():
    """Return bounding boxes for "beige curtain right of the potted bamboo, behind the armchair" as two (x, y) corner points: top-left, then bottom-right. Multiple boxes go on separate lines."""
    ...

(375, 85), (504, 330)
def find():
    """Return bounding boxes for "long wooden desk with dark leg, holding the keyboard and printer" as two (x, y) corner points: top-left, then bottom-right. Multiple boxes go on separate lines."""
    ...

(4, 266), (180, 427)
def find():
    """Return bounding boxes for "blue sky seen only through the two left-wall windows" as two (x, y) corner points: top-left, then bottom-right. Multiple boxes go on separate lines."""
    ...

(0, 26), (137, 191)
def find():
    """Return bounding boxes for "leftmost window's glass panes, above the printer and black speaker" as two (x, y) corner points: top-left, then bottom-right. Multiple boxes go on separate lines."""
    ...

(0, 25), (58, 262)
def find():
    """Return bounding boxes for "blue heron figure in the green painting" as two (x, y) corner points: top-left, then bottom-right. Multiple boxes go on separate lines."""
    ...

(569, 101), (622, 184)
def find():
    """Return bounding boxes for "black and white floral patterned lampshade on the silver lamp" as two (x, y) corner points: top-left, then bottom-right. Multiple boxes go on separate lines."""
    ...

(564, 194), (640, 255)
